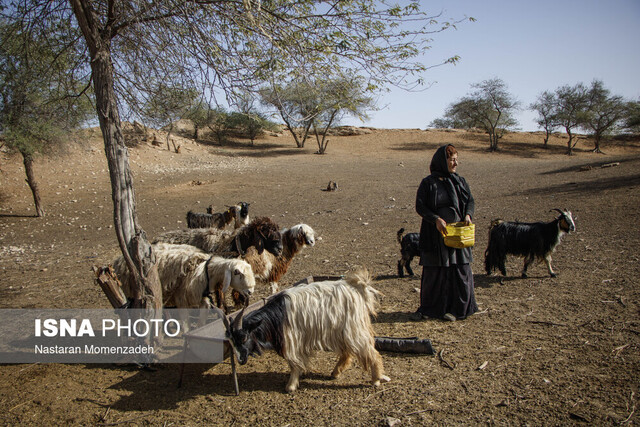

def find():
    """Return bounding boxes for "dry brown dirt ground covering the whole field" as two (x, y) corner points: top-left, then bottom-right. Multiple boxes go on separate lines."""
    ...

(0, 125), (640, 425)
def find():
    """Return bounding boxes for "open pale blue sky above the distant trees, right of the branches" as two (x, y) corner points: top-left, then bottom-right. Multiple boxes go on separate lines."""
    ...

(343, 0), (640, 131)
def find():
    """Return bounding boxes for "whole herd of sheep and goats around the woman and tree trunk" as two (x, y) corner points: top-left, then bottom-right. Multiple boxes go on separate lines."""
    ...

(113, 202), (575, 392)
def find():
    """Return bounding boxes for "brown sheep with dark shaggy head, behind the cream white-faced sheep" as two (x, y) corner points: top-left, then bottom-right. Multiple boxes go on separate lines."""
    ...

(153, 217), (282, 258)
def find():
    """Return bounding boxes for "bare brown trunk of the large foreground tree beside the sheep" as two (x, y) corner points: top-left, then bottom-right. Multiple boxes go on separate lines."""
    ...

(70, 0), (162, 309)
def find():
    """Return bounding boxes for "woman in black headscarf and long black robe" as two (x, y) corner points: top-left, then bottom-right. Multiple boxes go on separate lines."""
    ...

(411, 144), (478, 321)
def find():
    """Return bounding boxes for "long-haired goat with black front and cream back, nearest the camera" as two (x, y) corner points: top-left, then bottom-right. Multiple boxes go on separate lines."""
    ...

(223, 269), (389, 392)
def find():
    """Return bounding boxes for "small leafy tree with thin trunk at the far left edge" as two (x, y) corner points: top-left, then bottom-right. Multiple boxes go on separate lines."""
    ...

(0, 20), (92, 217)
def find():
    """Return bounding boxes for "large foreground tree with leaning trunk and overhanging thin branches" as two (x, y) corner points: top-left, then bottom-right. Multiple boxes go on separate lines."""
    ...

(2, 0), (470, 307)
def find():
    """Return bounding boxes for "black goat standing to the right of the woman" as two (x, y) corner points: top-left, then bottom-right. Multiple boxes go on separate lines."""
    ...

(484, 209), (576, 277)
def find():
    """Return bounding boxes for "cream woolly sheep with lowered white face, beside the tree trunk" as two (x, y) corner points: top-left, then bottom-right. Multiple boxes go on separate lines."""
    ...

(113, 243), (256, 311)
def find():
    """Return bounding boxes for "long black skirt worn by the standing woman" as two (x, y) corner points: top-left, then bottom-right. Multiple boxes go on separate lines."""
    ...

(418, 264), (478, 319)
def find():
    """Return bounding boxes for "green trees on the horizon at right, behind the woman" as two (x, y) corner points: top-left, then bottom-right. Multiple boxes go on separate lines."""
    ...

(429, 78), (640, 155)
